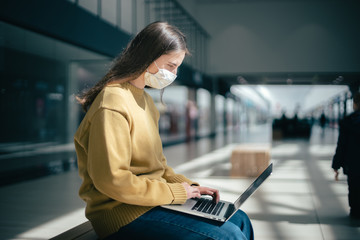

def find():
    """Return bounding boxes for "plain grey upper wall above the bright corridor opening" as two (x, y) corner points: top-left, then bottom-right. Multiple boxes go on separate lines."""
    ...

(184, 0), (360, 91)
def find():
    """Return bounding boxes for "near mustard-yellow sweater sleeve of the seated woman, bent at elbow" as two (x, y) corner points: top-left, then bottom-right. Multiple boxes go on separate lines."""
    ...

(87, 109), (187, 206)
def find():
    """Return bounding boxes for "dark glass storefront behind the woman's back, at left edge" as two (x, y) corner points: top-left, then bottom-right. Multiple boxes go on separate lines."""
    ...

(0, 22), (107, 184)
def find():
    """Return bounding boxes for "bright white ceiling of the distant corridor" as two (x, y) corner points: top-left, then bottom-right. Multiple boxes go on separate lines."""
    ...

(231, 85), (349, 117)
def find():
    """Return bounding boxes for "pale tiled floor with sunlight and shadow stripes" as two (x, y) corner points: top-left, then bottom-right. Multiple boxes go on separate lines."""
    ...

(0, 125), (360, 240)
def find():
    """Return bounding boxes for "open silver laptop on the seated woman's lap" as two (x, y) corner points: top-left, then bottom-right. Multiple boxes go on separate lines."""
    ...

(161, 163), (273, 222)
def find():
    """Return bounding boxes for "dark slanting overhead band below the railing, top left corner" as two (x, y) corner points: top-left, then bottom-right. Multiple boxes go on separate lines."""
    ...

(0, 0), (130, 56)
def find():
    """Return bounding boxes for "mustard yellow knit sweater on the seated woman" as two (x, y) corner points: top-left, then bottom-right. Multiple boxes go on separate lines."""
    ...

(74, 83), (196, 238)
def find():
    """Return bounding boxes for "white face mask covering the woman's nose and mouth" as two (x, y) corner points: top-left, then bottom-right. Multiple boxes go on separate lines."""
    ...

(144, 62), (177, 89)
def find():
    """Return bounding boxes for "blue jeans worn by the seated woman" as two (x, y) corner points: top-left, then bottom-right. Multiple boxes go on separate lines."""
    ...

(106, 207), (254, 240)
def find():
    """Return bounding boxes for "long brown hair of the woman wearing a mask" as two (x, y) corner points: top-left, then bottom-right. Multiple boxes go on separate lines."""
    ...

(76, 22), (189, 112)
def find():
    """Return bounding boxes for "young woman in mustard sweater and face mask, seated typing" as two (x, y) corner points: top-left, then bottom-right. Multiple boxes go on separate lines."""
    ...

(74, 22), (253, 239)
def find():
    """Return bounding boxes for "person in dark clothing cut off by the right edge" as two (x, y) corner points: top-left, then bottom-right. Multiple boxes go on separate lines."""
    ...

(332, 93), (360, 219)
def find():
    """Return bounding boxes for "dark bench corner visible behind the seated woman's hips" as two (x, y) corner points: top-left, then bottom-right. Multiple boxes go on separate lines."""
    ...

(50, 221), (99, 240)
